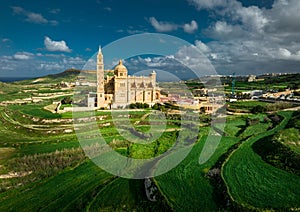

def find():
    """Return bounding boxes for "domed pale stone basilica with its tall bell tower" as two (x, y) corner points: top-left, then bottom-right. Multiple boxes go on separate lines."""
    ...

(88, 48), (160, 109)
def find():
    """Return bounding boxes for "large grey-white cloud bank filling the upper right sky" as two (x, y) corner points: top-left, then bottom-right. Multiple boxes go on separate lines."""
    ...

(187, 0), (300, 74)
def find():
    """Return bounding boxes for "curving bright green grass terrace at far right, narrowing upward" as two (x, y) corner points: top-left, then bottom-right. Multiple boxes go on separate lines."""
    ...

(222, 112), (300, 209)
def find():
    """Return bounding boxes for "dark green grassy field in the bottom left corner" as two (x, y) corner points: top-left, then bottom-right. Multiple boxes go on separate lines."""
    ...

(0, 162), (114, 211)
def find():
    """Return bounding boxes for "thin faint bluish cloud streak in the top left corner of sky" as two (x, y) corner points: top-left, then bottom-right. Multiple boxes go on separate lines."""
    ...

(11, 7), (58, 25)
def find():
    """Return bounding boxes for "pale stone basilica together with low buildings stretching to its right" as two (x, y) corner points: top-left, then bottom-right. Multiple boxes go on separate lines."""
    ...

(76, 48), (224, 113)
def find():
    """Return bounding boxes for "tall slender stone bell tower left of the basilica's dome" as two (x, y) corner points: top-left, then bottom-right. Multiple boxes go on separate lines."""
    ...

(97, 46), (105, 108)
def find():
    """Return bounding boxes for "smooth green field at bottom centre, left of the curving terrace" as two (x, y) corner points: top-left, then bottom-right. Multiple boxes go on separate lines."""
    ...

(155, 136), (238, 211)
